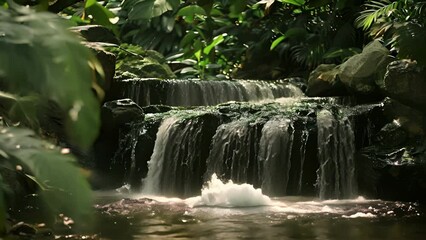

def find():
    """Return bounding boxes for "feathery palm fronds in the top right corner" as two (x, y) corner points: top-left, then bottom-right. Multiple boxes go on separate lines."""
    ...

(356, 0), (426, 66)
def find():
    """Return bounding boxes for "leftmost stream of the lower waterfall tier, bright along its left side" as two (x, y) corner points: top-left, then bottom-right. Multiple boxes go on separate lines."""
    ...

(142, 113), (219, 196)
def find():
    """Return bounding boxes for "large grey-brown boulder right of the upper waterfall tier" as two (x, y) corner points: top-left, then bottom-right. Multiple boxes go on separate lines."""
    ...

(339, 41), (391, 94)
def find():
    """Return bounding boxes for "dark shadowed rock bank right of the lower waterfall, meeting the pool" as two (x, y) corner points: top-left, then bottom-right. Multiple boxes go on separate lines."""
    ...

(356, 99), (426, 202)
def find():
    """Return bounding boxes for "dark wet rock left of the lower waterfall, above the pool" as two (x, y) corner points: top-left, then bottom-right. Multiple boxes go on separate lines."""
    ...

(94, 99), (144, 187)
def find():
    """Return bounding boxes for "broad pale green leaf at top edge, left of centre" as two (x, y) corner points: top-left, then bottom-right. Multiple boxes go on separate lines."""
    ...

(129, 0), (179, 20)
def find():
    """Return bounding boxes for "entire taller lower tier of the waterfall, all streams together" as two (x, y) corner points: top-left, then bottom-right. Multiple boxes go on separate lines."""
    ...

(115, 87), (362, 199)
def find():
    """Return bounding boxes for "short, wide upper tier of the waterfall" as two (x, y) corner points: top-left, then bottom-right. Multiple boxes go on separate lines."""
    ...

(117, 79), (304, 106)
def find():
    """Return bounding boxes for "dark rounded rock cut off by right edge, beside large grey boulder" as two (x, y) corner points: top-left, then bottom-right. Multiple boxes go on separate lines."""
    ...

(384, 60), (426, 113)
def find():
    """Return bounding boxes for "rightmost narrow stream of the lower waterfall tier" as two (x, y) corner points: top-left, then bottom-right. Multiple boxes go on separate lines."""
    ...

(317, 110), (356, 199)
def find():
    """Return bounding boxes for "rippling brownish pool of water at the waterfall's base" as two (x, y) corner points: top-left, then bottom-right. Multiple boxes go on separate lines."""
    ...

(96, 192), (426, 240)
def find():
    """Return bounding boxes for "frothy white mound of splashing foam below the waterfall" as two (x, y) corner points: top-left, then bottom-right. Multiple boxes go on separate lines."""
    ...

(185, 174), (272, 208)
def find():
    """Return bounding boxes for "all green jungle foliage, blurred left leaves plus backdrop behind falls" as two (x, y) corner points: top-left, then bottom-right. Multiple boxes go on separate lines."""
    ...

(0, 0), (426, 236)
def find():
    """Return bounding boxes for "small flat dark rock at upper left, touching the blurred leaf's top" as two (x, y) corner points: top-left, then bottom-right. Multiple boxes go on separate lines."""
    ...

(71, 25), (119, 44)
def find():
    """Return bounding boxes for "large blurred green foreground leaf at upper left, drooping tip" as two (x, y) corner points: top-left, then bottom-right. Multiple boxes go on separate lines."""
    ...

(0, 9), (100, 148)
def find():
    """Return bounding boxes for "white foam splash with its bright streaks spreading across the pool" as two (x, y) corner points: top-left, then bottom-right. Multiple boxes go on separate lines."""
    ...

(136, 174), (378, 218)
